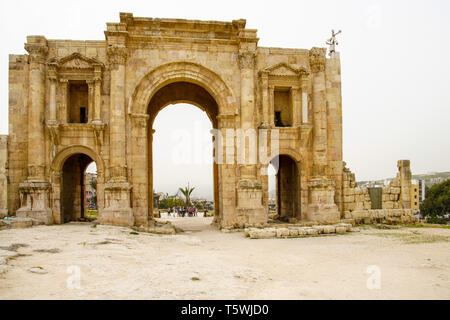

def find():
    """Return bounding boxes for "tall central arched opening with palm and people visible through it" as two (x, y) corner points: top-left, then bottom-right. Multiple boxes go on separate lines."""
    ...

(148, 81), (220, 225)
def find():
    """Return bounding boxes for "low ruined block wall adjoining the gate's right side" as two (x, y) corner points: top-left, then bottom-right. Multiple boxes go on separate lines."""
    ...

(342, 160), (415, 223)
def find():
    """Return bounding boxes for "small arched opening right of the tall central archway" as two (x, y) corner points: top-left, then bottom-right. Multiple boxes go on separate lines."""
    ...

(268, 155), (301, 221)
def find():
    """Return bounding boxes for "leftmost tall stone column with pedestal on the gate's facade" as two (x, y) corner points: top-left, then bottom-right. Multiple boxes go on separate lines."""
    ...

(16, 36), (53, 224)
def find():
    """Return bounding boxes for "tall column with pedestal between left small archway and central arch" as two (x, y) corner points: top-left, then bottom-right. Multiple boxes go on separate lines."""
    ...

(99, 45), (134, 226)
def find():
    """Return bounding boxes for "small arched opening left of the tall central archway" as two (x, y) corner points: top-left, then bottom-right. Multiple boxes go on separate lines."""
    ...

(60, 153), (97, 223)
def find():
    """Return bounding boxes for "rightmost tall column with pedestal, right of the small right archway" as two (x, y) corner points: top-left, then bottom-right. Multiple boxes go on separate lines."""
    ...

(307, 48), (340, 223)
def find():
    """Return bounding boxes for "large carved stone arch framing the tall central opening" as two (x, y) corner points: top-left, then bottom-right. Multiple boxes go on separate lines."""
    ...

(128, 62), (237, 224)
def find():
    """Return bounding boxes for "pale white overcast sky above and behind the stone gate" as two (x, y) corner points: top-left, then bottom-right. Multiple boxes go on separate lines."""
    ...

(0, 0), (450, 200)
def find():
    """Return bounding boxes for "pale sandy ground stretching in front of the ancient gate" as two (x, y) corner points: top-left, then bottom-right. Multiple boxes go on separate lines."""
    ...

(0, 217), (450, 299)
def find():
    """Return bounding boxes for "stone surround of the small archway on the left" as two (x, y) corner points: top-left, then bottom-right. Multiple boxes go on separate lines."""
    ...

(51, 146), (105, 224)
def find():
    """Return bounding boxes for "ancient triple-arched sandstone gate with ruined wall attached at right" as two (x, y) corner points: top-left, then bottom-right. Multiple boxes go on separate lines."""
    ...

(0, 13), (411, 227)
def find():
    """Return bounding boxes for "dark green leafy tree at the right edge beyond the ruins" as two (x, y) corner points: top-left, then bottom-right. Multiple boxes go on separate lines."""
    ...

(420, 180), (450, 221)
